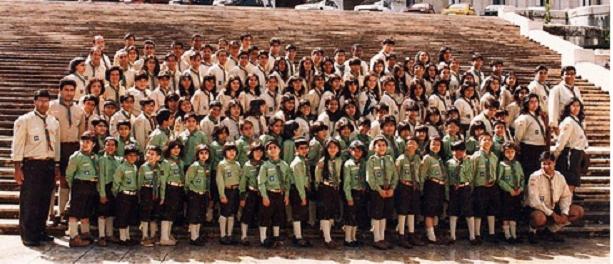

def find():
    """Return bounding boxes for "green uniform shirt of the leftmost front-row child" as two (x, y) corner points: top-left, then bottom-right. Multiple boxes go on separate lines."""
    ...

(66, 151), (98, 187)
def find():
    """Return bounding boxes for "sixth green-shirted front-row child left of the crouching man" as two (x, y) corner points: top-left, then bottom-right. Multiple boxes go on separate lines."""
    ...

(366, 136), (400, 250)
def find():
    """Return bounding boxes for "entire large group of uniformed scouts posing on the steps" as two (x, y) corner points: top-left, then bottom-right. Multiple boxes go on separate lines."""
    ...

(12, 34), (587, 250)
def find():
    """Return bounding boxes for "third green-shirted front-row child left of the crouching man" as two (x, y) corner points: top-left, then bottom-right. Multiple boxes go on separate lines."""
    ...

(446, 141), (478, 245)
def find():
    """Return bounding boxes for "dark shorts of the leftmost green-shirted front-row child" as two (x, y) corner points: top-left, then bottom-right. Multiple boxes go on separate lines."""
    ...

(68, 180), (99, 219)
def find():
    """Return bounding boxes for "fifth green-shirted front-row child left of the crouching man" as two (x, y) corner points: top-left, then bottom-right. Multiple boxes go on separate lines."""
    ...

(395, 136), (423, 248)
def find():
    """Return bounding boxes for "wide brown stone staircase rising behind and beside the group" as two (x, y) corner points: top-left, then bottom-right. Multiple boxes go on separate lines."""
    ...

(0, 2), (610, 236)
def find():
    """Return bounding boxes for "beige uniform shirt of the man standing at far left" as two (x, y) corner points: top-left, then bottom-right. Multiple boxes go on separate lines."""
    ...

(11, 110), (60, 161)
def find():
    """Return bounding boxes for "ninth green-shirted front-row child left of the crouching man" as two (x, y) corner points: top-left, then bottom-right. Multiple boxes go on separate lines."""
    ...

(289, 138), (311, 247)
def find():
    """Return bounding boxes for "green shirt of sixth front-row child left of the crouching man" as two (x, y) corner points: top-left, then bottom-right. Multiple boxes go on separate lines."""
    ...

(366, 155), (398, 191)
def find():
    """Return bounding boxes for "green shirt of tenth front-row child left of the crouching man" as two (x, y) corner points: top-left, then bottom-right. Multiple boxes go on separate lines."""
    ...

(258, 160), (292, 199)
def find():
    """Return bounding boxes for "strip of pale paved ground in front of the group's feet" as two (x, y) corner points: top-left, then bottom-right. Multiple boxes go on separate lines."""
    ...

(0, 236), (610, 264)
